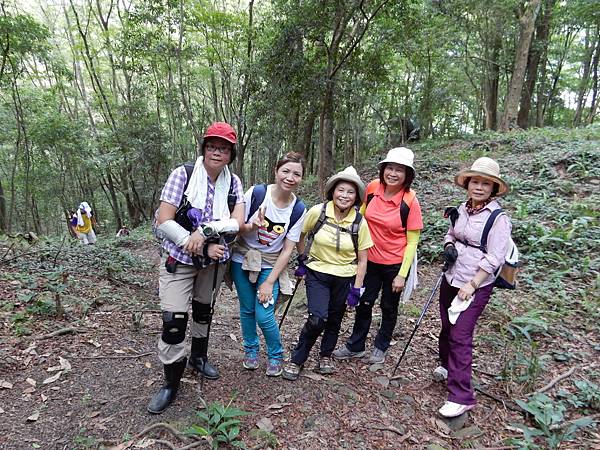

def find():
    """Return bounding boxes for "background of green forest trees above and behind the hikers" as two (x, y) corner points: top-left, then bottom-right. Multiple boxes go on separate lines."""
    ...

(0, 0), (600, 234)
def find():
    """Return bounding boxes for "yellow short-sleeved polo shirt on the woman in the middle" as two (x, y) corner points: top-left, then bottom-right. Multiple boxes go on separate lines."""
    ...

(302, 201), (373, 277)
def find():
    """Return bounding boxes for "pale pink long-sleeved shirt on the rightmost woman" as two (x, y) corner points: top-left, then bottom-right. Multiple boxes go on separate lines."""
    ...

(444, 200), (512, 288)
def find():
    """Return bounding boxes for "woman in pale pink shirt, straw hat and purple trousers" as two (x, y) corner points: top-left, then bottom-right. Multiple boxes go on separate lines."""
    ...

(433, 157), (511, 417)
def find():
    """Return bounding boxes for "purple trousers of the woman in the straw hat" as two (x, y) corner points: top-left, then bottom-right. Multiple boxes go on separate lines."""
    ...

(439, 277), (494, 405)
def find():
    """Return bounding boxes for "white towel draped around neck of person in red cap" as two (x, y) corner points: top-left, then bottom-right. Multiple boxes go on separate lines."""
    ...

(185, 156), (231, 220)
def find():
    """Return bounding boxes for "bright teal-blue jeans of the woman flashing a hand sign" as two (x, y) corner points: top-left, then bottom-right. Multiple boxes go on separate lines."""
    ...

(231, 261), (283, 359)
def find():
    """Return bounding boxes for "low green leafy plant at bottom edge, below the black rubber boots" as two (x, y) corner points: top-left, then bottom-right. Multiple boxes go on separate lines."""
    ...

(186, 399), (250, 449)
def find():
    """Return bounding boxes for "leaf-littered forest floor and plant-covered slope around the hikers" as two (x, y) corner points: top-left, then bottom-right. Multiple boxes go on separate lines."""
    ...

(0, 127), (600, 450)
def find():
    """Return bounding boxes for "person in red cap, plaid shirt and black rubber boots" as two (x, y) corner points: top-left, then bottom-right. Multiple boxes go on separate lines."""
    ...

(148, 122), (244, 414)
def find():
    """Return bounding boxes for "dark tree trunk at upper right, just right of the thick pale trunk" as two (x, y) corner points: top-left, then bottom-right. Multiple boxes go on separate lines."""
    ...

(517, 0), (556, 129)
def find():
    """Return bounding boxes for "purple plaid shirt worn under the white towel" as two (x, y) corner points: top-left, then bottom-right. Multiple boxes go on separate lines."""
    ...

(160, 166), (244, 266)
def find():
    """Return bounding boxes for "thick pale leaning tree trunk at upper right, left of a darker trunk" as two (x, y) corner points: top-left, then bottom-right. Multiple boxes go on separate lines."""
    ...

(500, 0), (540, 131)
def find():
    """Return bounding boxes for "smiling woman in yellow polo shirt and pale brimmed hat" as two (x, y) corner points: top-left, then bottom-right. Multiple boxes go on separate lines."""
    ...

(283, 167), (373, 380)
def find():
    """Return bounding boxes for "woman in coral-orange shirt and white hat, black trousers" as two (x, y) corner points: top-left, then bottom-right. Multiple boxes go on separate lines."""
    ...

(333, 147), (423, 364)
